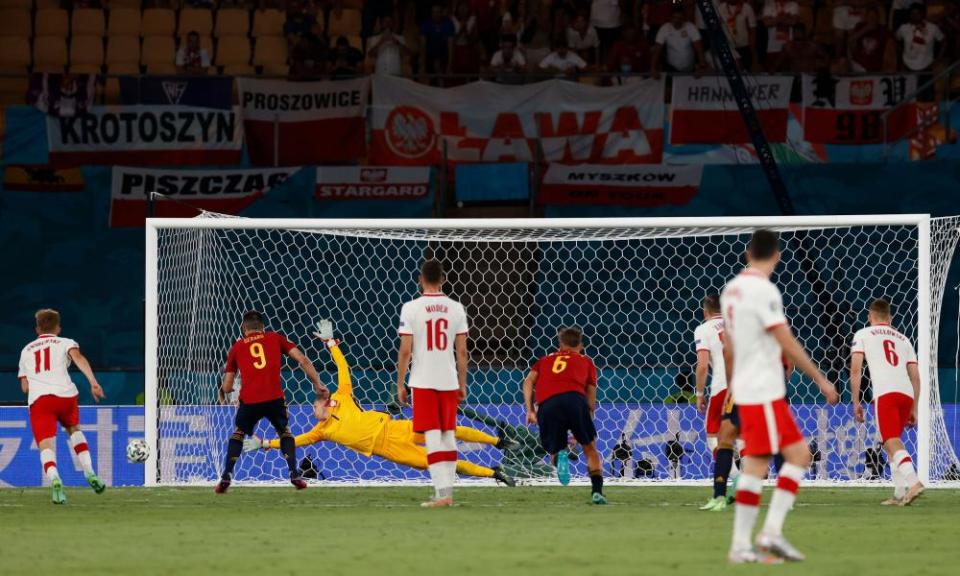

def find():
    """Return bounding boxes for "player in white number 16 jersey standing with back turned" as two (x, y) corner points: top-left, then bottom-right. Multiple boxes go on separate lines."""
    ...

(397, 260), (469, 508)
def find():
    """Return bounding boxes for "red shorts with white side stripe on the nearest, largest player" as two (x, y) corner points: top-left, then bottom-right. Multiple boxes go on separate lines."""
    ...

(737, 398), (803, 456)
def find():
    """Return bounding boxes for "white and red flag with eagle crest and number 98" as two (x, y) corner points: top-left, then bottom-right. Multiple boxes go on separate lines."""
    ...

(803, 74), (917, 144)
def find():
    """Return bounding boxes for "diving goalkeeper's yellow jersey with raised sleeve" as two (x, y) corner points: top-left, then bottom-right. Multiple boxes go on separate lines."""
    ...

(270, 346), (390, 456)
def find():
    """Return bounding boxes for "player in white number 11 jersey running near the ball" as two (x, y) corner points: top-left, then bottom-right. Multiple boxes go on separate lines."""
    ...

(18, 309), (106, 504)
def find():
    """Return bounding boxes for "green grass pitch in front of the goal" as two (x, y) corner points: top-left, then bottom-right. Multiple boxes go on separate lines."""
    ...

(0, 486), (960, 576)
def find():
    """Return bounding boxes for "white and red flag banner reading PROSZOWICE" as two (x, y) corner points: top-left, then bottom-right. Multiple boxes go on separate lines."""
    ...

(237, 78), (370, 166)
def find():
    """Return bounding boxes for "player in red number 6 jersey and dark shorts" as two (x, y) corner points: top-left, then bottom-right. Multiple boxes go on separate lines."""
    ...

(523, 328), (607, 504)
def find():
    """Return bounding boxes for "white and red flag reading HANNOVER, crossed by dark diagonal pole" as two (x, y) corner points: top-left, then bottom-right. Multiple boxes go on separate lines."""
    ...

(670, 76), (793, 144)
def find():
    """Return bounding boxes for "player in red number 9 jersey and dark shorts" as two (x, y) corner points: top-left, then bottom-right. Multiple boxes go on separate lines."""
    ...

(216, 311), (329, 494)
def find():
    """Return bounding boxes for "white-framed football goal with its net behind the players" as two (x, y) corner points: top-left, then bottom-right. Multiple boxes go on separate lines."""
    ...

(146, 215), (958, 485)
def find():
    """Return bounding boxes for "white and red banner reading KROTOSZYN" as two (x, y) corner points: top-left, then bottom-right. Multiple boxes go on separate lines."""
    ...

(47, 106), (242, 166)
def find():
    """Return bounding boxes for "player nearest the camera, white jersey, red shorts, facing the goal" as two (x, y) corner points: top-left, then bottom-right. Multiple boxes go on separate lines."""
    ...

(720, 230), (839, 563)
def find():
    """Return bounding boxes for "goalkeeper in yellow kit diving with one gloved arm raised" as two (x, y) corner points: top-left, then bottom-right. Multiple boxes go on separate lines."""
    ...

(243, 320), (516, 486)
